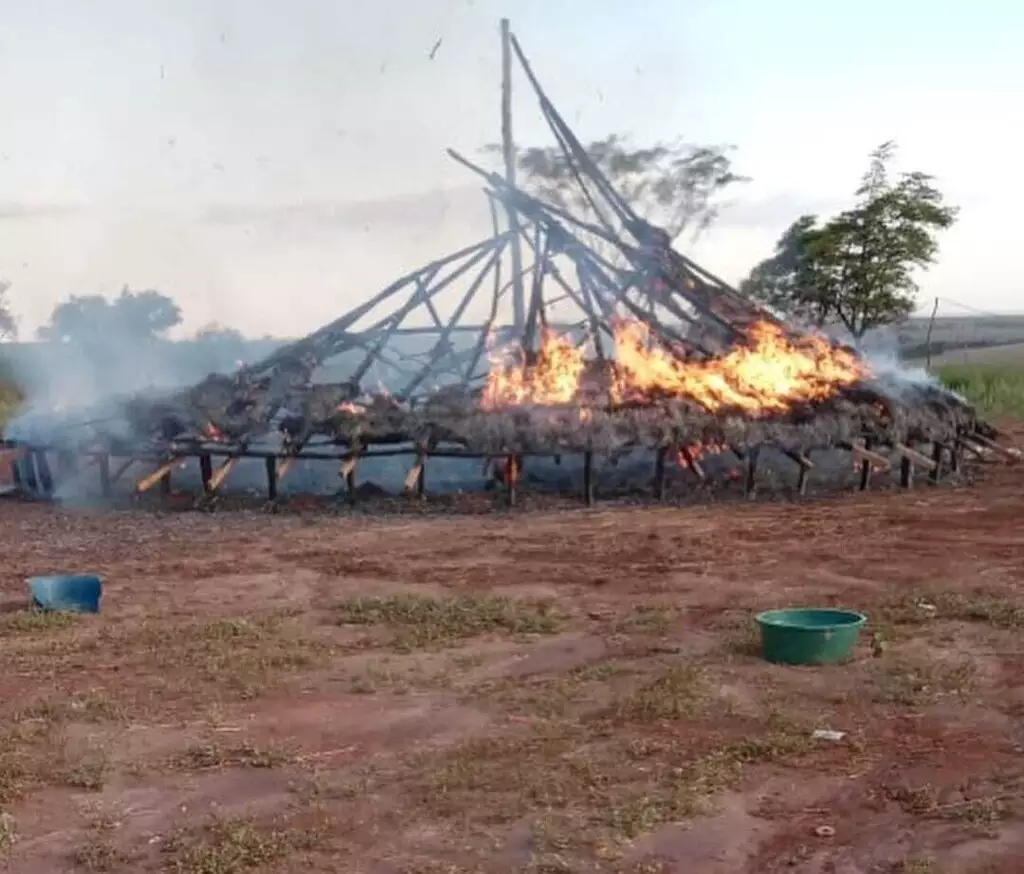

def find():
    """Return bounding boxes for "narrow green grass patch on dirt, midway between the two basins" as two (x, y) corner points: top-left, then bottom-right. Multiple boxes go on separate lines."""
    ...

(335, 595), (563, 650)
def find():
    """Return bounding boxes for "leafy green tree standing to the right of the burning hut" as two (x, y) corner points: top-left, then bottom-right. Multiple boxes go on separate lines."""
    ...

(740, 142), (957, 339)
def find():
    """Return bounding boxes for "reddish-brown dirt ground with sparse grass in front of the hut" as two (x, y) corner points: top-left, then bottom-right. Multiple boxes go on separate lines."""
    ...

(0, 458), (1024, 874)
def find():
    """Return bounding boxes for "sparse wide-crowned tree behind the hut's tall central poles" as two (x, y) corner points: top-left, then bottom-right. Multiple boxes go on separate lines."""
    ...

(485, 134), (745, 245)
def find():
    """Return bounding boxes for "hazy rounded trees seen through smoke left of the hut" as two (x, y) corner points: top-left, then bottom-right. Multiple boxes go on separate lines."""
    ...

(38, 286), (181, 344)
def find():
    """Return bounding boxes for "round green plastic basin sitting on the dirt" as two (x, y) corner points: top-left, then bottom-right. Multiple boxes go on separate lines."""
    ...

(757, 607), (867, 664)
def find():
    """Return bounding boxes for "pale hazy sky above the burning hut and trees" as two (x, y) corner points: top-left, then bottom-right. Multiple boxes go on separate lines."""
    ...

(0, 0), (1024, 336)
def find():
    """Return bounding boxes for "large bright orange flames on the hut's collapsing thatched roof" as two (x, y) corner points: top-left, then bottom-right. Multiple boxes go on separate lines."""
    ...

(483, 321), (866, 414)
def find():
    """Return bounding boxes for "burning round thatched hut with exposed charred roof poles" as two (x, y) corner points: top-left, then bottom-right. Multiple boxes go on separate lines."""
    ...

(0, 26), (1016, 501)
